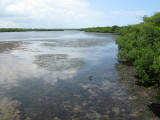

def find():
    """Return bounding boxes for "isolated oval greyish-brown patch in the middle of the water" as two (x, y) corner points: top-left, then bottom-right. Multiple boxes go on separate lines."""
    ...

(34, 54), (85, 71)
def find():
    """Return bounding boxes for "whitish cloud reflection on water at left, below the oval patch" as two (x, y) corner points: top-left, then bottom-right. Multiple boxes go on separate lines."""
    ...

(0, 54), (77, 88)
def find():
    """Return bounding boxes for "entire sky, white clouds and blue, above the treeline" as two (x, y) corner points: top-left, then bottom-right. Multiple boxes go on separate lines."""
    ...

(0, 0), (160, 28)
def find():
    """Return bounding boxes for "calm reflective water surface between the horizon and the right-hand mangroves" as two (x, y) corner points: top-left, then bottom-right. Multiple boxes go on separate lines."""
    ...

(0, 31), (158, 120)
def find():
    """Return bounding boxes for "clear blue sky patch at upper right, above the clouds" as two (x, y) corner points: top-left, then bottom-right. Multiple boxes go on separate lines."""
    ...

(83, 0), (160, 13)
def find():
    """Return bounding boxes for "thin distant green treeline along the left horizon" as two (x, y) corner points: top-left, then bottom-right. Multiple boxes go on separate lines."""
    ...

(0, 28), (65, 32)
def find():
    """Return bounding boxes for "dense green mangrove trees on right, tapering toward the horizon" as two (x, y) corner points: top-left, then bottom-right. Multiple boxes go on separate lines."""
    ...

(80, 12), (160, 99)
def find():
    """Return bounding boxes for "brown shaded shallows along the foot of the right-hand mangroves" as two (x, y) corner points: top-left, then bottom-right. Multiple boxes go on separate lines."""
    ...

(115, 64), (160, 120)
